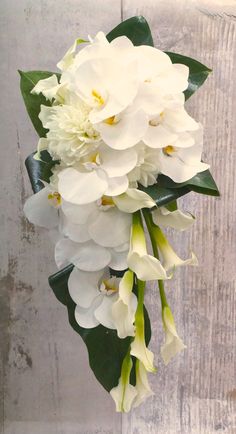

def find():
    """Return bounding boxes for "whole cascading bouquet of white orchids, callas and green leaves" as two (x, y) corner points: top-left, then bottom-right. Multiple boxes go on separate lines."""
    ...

(20, 17), (219, 412)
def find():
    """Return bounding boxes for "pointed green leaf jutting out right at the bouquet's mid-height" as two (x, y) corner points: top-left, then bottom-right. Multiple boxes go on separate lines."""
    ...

(158, 170), (220, 196)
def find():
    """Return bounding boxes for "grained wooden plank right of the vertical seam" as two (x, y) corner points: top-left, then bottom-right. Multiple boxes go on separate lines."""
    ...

(122, 0), (236, 434)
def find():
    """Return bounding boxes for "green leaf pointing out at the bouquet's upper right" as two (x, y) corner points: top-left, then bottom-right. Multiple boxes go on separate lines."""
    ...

(166, 51), (212, 100)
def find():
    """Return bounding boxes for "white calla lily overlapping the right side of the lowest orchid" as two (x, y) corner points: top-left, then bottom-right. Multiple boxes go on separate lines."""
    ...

(112, 270), (137, 339)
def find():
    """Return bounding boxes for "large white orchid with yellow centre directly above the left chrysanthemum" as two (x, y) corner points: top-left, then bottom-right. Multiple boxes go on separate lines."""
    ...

(62, 56), (138, 123)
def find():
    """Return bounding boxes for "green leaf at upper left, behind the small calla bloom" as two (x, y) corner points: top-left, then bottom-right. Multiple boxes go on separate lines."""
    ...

(19, 71), (60, 137)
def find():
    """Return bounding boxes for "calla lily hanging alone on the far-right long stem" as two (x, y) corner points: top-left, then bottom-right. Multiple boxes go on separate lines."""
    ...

(161, 306), (186, 365)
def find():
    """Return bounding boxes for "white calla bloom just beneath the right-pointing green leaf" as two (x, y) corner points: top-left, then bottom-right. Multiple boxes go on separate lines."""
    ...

(152, 206), (195, 231)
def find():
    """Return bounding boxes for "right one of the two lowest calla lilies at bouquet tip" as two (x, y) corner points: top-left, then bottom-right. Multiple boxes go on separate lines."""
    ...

(133, 360), (154, 407)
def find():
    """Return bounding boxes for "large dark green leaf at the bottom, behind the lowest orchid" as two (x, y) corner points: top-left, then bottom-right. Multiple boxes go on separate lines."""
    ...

(49, 265), (151, 391)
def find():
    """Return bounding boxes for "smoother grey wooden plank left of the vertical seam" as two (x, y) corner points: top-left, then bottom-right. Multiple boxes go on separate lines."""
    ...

(0, 0), (121, 434)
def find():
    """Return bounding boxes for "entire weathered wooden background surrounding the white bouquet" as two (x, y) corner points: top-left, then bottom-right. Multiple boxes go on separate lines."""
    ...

(0, 0), (236, 434)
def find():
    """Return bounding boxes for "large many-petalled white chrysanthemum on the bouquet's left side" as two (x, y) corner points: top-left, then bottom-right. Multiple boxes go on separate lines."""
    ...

(39, 98), (100, 165)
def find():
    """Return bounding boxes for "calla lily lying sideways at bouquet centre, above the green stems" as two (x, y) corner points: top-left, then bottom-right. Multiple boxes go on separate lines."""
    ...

(113, 188), (156, 213)
